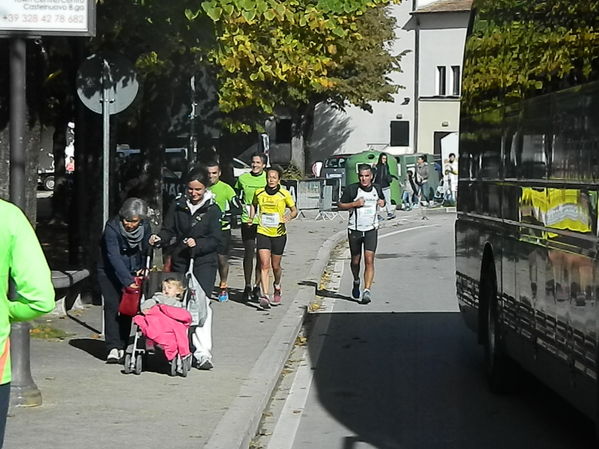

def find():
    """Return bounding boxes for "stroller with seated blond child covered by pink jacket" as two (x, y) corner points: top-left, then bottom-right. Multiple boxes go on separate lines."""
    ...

(124, 272), (192, 377)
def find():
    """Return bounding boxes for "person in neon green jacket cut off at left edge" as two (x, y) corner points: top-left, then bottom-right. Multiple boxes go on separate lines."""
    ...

(0, 200), (54, 447)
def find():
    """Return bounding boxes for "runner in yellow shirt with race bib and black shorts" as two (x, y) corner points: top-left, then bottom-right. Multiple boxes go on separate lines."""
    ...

(249, 166), (298, 308)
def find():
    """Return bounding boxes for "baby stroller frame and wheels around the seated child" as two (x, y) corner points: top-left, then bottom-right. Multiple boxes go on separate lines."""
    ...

(124, 252), (209, 377)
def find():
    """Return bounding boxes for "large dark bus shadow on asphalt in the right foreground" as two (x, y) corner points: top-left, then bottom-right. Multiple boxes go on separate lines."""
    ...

(309, 313), (595, 449)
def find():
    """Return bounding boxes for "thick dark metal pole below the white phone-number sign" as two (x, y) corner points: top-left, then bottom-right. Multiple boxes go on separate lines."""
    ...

(9, 37), (42, 407)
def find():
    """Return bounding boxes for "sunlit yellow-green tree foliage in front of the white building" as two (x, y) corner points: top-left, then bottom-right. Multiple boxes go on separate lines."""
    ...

(196, 0), (400, 171)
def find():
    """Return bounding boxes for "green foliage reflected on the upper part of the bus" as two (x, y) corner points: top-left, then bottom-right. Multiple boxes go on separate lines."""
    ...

(463, 0), (599, 112)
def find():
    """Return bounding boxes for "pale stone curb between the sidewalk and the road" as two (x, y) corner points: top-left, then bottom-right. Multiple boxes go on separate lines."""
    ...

(204, 229), (347, 449)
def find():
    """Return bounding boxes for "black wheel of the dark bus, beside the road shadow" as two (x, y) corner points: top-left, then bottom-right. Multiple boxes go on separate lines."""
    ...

(480, 267), (516, 394)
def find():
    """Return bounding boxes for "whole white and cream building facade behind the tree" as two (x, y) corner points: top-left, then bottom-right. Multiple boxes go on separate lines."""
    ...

(310, 0), (472, 160)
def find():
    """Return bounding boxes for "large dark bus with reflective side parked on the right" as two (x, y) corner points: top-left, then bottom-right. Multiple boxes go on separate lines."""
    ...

(455, 0), (599, 422)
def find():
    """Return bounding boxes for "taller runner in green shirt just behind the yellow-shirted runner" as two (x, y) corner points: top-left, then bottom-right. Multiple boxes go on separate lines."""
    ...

(235, 153), (268, 302)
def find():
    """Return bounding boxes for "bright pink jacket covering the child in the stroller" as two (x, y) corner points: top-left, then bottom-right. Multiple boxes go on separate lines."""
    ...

(133, 304), (191, 362)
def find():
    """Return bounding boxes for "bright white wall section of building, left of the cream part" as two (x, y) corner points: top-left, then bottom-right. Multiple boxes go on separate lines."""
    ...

(311, 1), (415, 160)
